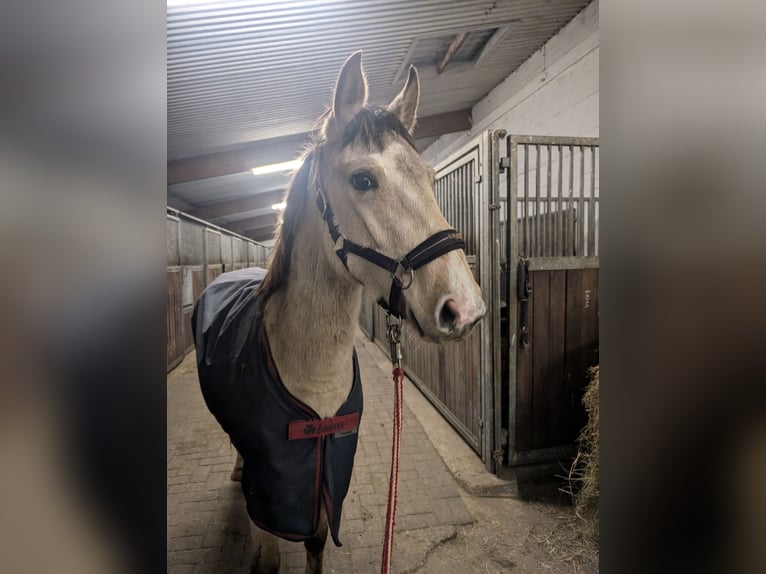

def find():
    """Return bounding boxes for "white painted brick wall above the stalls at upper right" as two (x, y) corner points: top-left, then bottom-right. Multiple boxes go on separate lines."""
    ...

(423, 0), (599, 165)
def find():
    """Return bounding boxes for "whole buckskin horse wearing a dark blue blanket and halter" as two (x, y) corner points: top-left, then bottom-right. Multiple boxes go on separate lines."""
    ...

(192, 52), (486, 574)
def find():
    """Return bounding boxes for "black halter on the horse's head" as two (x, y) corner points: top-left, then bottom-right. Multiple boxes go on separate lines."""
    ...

(316, 178), (465, 319)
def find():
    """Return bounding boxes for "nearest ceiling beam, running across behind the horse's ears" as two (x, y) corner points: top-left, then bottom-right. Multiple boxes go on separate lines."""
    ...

(168, 108), (471, 185)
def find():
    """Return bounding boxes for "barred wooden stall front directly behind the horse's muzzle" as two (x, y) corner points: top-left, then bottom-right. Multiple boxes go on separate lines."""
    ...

(372, 130), (505, 470)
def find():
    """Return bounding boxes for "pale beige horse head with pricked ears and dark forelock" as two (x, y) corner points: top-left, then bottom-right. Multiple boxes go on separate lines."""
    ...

(314, 52), (486, 342)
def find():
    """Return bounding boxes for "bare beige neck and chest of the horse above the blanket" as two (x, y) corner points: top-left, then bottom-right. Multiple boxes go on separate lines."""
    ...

(264, 187), (362, 418)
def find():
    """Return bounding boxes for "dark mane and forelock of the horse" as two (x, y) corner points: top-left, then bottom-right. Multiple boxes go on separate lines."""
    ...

(257, 105), (417, 303)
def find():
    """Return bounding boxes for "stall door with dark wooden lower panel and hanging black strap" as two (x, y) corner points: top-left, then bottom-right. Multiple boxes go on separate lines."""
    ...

(508, 136), (599, 465)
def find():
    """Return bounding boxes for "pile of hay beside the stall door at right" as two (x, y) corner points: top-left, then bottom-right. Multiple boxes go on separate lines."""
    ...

(568, 366), (599, 538)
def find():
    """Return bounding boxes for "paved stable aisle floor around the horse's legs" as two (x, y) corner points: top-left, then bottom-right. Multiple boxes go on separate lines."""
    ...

(167, 334), (598, 574)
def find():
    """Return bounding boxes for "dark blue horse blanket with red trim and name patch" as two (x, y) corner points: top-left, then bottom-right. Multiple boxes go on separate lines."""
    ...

(192, 268), (362, 546)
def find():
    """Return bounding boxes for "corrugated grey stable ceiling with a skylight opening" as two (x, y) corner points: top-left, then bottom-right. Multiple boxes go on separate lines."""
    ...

(167, 0), (588, 237)
